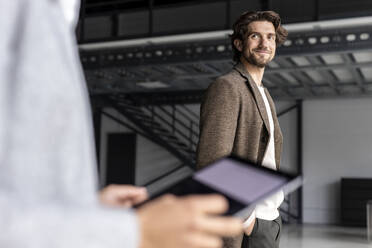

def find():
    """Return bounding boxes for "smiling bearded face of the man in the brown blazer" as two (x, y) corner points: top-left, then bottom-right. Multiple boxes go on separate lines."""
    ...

(236, 21), (276, 68)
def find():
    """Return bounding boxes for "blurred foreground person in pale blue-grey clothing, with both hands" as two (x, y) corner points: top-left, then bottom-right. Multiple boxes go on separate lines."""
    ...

(0, 0), (241, 248)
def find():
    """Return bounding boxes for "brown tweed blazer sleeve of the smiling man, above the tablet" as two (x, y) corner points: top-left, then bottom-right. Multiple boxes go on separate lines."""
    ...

(196, 78), (240, 169)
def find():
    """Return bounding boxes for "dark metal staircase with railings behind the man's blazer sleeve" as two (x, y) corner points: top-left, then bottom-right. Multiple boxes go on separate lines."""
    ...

(104, 95), (199, 169)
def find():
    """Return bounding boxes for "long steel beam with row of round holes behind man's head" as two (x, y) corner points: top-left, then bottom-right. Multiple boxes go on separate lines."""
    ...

(80, 26), (372, 69)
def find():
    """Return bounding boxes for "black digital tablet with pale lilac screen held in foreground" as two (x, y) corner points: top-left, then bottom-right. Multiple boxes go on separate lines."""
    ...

(144, 156), (302, 218)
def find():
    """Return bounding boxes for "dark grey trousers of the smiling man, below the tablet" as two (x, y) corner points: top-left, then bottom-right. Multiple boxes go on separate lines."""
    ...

(242, 216), (282, 248)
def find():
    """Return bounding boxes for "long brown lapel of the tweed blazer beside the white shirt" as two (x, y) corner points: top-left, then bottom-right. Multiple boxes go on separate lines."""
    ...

(234, 63), (270, 134)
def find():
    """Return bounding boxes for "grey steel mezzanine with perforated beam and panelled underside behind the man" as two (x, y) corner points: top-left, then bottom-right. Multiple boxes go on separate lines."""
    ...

(80, 0), (372, 103)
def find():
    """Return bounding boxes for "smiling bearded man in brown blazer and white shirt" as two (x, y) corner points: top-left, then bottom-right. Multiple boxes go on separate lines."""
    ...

(197, 11), (287, 248)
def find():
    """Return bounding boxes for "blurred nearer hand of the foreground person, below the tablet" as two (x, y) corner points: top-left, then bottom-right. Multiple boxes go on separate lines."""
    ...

(138, 195), (243, 248)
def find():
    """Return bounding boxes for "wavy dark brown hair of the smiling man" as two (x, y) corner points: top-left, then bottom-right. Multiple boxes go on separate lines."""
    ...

(229, 11), (288, 62)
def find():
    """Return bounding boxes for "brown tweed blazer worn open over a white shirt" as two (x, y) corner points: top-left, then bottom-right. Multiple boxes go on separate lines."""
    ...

(196, 64), (283, 248)
